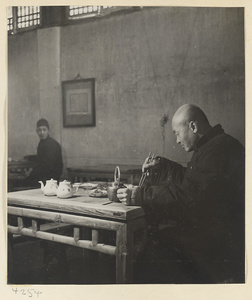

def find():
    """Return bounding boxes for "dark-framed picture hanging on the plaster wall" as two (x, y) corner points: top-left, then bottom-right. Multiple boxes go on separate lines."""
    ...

(62, 78), (95, 127)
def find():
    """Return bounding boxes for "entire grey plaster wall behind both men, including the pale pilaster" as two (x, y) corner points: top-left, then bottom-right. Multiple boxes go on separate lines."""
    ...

(8, 7), (245, 176)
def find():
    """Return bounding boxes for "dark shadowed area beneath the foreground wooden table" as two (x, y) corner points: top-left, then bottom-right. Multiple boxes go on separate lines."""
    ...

(8, 238), (115, 284)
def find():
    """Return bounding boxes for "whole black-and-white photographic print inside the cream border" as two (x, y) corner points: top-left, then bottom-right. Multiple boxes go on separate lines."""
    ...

(2, 2), (252, 299)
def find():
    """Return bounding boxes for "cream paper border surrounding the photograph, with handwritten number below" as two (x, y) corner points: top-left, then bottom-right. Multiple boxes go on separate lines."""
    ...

(0, 0), (252, 300)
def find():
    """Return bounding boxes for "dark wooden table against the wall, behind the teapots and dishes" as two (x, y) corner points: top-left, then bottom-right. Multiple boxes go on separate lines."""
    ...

(67, 164), (142, 184)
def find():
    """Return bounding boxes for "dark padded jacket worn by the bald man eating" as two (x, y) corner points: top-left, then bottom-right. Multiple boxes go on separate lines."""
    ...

(136, 125), (245, 263)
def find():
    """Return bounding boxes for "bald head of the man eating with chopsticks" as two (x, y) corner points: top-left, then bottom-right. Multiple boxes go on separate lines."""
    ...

(172, 104), (211, 152)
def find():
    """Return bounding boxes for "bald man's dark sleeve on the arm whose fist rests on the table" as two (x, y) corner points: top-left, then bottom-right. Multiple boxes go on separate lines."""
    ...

(135, 151), (226, 209)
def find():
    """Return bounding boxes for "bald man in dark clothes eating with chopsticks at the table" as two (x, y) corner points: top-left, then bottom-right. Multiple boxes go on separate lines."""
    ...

(117, 104), (245, 283)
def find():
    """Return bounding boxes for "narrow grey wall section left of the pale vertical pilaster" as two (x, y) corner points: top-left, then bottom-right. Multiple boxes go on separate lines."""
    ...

(8, 31), (40, 159)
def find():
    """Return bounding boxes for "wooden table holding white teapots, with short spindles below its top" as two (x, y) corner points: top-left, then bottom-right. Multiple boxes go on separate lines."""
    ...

(8, 189), (146, 283)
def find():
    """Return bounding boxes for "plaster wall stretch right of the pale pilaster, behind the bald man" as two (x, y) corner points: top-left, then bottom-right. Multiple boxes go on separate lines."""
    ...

(61, 8), (244, 166)
